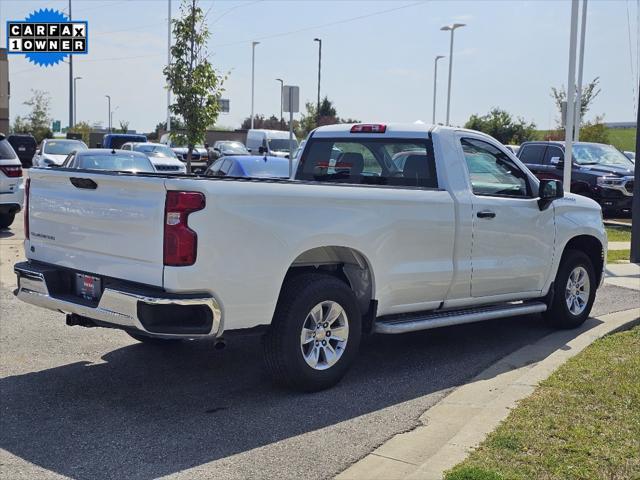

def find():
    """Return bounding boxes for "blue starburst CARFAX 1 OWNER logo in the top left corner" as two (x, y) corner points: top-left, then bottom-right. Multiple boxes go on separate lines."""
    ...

(7, 9), (88, 67)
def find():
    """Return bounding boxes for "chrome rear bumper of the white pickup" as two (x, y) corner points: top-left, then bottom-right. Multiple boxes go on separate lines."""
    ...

(14, 262), (222, 338)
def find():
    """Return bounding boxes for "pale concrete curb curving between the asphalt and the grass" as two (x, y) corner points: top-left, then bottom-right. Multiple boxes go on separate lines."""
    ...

(336, 308), (640, 480)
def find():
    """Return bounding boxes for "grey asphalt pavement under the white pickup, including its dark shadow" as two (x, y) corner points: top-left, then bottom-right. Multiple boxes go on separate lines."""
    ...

(0, 222), (640, 480)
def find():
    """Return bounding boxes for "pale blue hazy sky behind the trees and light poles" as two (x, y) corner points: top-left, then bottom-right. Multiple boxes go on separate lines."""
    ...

(0, 0), (638, 131)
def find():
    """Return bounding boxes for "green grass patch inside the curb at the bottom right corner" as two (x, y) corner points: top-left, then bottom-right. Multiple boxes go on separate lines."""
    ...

(445, 327), (640, 480)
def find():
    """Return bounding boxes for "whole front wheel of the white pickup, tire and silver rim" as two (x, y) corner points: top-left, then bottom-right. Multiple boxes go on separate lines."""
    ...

(545, 250), (597, 328)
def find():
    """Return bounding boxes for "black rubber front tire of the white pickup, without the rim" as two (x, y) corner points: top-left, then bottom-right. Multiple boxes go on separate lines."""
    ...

(544, 250), (598, 329)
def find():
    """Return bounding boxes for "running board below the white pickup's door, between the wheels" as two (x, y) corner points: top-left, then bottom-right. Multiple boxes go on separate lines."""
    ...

(373, 301), (547, 334)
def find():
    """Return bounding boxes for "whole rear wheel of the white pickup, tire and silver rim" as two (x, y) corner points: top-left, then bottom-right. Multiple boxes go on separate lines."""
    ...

(264, 273), (362, 392)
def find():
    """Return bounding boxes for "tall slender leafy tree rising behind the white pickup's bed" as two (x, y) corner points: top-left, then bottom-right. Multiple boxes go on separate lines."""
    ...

(164, 0), (225, 173)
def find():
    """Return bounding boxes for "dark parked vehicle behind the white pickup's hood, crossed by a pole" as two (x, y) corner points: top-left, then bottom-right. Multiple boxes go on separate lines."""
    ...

(518, 142), (634, 215)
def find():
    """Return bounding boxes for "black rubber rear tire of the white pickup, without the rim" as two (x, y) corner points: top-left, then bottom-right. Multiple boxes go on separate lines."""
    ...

(263, 273), (362, 392)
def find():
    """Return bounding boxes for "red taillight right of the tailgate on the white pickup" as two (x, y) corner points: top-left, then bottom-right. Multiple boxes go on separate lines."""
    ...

(164, 192), (205, 267)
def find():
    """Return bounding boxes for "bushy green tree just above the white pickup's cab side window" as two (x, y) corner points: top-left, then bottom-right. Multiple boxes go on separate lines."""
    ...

(464, 108), (536, 144)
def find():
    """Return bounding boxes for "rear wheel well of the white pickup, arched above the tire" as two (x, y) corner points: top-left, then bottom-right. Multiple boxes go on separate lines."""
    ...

(285, 246), (373, 315)
